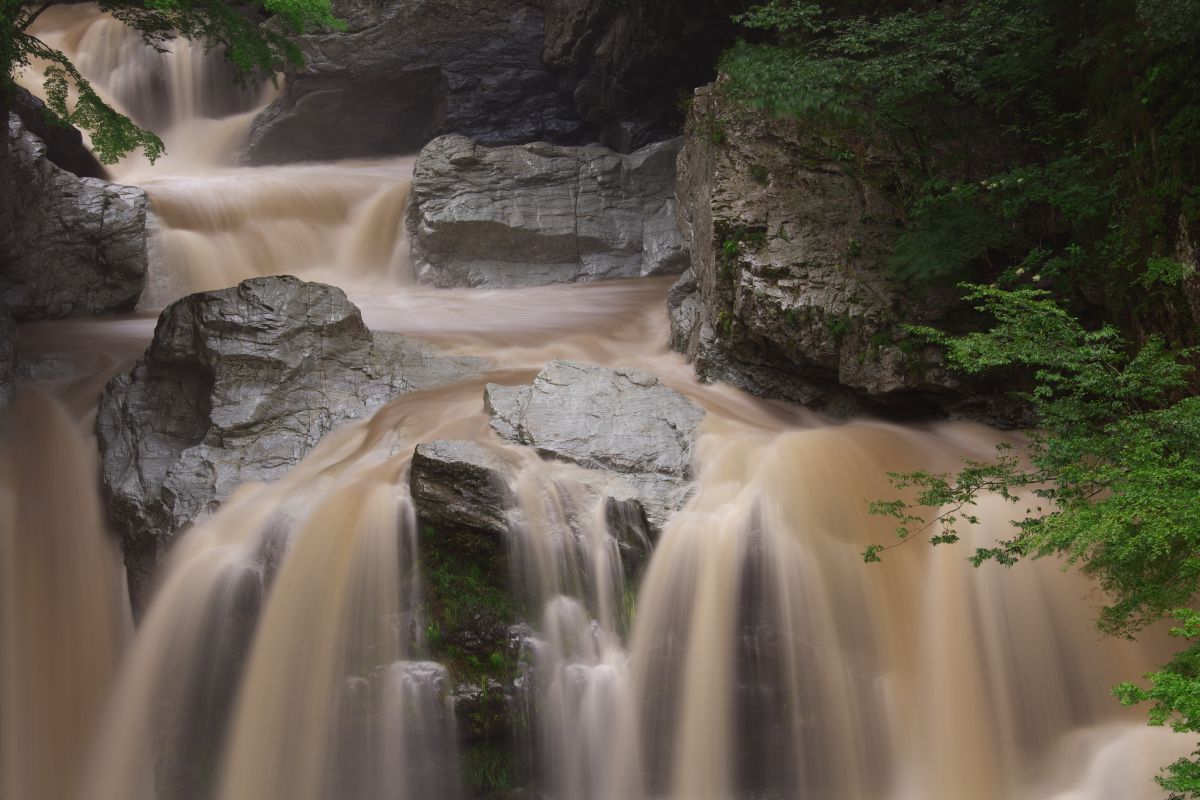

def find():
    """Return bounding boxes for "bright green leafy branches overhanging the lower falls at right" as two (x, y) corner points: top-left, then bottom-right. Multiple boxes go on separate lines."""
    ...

(863, 285), (1200, 798)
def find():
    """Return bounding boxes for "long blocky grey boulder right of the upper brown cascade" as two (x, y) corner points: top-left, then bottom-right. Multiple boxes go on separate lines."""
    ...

(408, 136), (688, 288)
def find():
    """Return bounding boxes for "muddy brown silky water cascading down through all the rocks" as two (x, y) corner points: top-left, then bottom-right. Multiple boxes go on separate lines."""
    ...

(0, 6), (1190, 800)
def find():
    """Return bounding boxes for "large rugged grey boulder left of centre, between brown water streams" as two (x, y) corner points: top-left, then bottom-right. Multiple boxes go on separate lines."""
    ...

(96, 276), (482, 599)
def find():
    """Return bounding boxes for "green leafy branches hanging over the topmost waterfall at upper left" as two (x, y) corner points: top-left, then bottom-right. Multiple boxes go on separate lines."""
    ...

(0, 0), (344, 164)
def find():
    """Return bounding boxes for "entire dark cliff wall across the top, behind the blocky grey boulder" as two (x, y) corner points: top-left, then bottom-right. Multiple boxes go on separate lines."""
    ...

(247, 0), (745, 164)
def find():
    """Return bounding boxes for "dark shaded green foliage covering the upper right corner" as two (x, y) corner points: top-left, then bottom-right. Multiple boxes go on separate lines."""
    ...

(720, 0), (1200, 331)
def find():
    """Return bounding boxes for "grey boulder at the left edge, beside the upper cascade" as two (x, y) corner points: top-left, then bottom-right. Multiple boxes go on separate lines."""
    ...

(0, 114), (148, 319)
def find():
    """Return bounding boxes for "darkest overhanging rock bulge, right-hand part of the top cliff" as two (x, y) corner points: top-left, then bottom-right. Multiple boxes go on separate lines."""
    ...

(544, 0), (750, 152)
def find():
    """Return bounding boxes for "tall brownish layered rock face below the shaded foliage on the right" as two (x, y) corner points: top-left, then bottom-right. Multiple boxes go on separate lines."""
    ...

(668, 88), (1002, 416)
